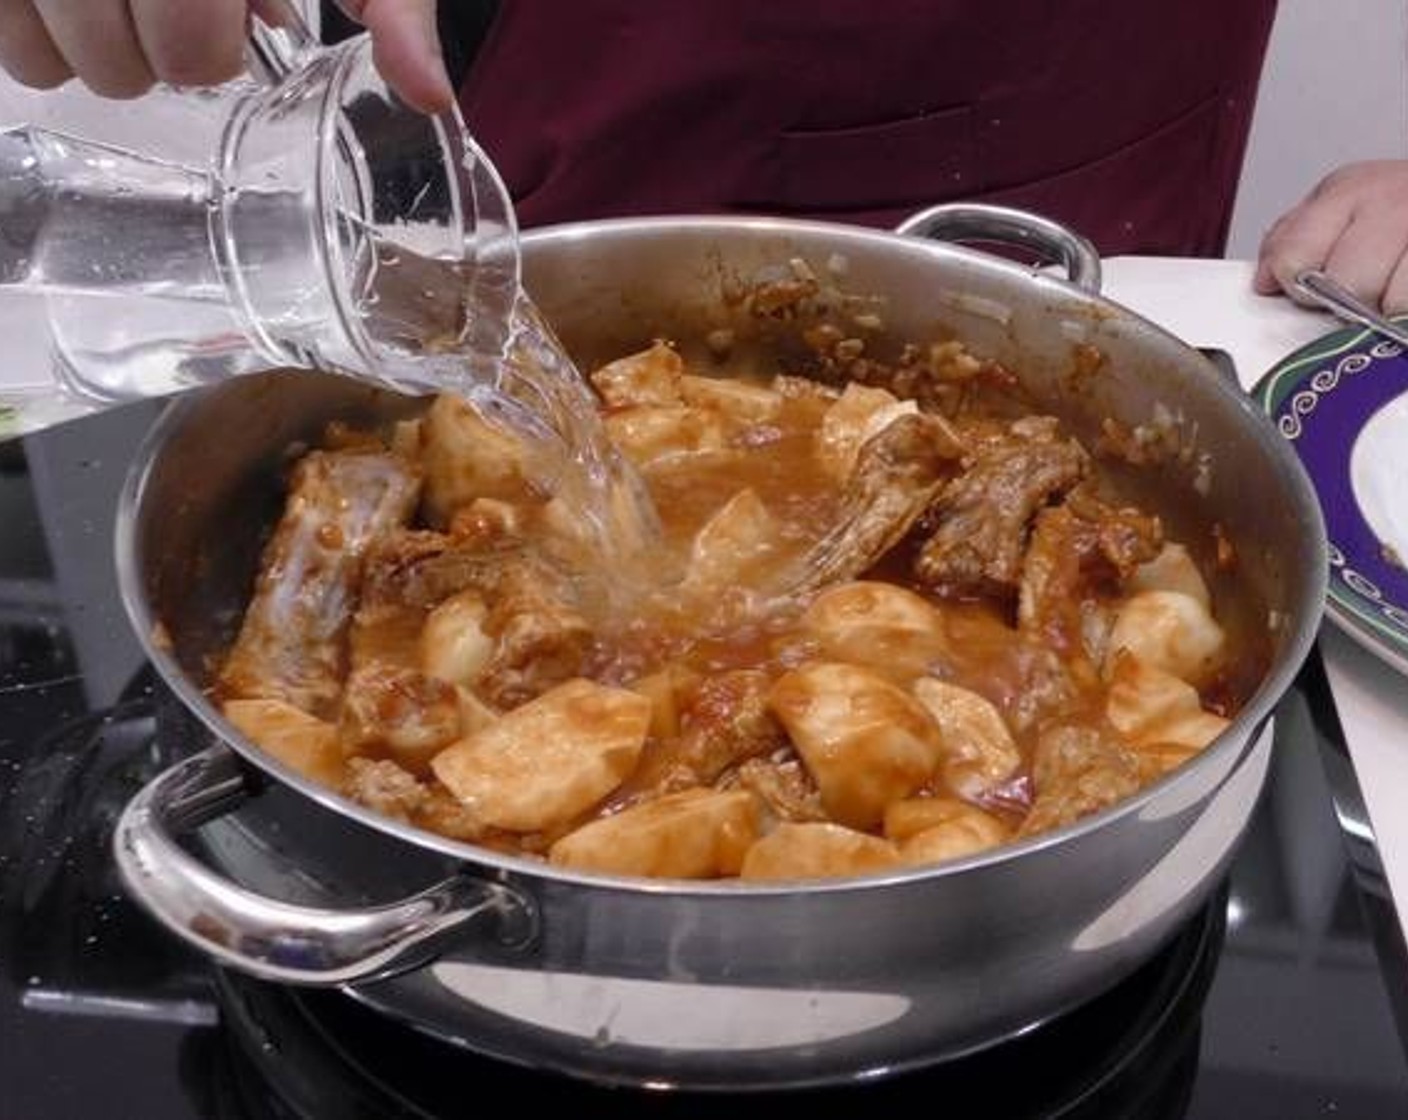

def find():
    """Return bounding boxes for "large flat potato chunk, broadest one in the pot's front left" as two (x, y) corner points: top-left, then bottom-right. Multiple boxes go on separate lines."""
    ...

(431, 679), (650, 833)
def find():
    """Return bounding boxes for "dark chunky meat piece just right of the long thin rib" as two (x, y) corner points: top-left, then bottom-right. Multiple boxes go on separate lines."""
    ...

(914, 417), (1088, 596)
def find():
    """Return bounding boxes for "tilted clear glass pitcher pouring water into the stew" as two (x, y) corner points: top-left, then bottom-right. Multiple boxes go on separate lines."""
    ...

(0, 10), (518, 437)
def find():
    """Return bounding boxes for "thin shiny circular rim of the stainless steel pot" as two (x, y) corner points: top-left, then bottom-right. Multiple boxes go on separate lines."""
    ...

(114, 208), (1329, 897)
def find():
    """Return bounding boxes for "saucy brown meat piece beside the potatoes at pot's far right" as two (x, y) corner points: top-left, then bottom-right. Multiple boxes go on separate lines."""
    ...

(1017, 490), (1163, 664)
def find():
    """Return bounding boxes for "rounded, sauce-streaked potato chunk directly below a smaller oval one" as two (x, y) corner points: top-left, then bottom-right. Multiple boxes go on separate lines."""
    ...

(767, 662), (942, 828)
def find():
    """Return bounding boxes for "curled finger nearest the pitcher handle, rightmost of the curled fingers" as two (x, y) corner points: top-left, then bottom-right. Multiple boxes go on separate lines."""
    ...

(128, 0), (248, 86)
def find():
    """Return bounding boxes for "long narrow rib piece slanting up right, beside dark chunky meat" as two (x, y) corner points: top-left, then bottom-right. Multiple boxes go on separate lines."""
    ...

(786, 413), (964, 595)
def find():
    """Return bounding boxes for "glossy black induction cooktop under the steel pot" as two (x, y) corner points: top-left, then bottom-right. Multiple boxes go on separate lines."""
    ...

(0, 404), (1408, 1120)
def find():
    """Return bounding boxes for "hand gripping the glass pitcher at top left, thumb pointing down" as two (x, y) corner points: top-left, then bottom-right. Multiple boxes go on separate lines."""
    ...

(0, 0), (453, 113)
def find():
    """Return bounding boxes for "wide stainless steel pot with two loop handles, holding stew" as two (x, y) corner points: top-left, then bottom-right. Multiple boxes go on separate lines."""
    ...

(115, 207), (1325, 1088)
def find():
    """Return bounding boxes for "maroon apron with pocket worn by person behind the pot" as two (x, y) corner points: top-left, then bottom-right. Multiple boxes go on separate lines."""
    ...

(460, 0), (1276, 255)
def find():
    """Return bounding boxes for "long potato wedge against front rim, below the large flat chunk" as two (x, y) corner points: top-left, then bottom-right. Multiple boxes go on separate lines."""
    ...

(548, 789), (759, 879)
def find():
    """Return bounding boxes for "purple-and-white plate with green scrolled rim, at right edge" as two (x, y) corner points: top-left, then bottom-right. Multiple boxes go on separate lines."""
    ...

(1253, 327), (1408, 673)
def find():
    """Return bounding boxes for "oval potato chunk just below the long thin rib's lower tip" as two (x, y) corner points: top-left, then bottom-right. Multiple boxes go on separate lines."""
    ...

(801, 579), (948, 680)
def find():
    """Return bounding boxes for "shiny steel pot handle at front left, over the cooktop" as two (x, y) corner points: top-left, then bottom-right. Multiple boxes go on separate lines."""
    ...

(113, 747), (534, 986)
